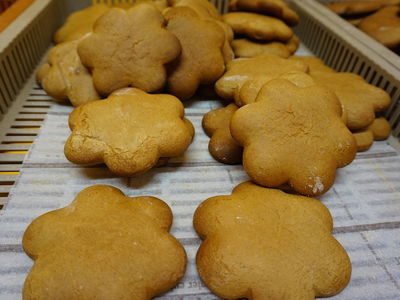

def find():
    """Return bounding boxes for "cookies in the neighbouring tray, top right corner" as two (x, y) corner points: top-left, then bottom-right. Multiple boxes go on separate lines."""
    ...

(327, 0), (400, 54)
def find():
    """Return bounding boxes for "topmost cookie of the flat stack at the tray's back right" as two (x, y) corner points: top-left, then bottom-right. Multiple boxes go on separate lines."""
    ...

(230, 0), (299, 26)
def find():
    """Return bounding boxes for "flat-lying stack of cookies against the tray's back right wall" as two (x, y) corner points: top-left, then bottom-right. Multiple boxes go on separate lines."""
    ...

(223, 0), (299, 58)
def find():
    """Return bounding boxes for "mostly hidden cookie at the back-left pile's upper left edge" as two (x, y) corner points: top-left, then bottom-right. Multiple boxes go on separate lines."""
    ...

(54, 4), (110, 43)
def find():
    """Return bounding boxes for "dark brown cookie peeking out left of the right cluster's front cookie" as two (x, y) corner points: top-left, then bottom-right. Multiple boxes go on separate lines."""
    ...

(202, 103), (243, 164)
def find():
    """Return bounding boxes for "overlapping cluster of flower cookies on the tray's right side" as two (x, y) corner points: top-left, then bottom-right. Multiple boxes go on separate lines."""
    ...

(203, 54), (390, 190)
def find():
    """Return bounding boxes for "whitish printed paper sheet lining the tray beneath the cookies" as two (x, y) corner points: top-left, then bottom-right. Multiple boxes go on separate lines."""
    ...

(0, 45), (400, 300)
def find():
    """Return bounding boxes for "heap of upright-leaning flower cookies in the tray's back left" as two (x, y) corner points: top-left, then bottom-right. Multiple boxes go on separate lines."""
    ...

(37, 0), (234, 106)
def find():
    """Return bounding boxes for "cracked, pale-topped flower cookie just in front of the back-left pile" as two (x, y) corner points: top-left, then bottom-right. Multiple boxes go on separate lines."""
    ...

(64, 88), (194, 176)
